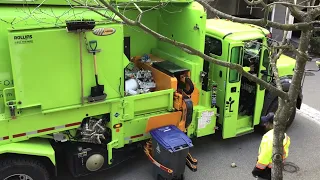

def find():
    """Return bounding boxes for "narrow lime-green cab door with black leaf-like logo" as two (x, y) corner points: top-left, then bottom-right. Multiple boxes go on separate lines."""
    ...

(222, 43), (243, 138)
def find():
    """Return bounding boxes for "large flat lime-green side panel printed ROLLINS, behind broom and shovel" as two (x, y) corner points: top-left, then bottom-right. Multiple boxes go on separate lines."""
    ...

(9, 24), (123, 110)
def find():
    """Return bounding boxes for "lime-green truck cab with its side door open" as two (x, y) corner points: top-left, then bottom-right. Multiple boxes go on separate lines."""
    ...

(202, 19), (302, 138)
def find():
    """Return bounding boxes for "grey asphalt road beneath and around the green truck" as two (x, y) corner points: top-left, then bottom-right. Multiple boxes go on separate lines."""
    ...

(57, 62), (320, 180)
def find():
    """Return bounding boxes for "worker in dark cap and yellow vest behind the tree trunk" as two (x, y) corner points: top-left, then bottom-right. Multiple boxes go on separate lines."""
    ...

(252, 112), (290, 180)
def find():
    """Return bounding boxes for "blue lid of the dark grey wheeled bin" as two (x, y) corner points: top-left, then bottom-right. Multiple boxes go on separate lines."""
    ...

(150, 125), (193, 152)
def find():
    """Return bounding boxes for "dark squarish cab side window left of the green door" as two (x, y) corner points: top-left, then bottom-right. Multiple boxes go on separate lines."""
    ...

(204, 36), (222, 56)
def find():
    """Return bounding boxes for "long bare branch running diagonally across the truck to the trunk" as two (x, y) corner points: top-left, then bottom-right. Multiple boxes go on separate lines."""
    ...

(73, 0), (288, 99)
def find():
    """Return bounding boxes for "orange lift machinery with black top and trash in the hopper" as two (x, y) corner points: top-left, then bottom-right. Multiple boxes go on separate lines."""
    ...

(129, 55), (199, 131)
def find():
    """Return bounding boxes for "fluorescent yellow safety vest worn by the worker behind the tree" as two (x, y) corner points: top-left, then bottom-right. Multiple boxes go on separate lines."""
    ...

(256, 129), (291, 169)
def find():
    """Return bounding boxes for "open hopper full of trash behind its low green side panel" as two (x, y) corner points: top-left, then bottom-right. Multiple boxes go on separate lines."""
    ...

(124, 55), (178, 116)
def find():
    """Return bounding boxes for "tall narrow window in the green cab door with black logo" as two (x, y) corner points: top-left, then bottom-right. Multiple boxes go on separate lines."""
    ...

(229, 47), (242, 83)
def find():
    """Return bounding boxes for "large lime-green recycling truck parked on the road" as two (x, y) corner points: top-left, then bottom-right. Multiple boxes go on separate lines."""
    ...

(0, 0), (302, 180)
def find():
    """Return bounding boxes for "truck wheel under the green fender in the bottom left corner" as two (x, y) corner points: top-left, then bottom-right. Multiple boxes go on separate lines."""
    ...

(0, 159), (50, 180)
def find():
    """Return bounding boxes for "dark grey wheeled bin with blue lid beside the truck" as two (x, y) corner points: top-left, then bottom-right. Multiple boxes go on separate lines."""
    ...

(150, 125), (193, 180)
